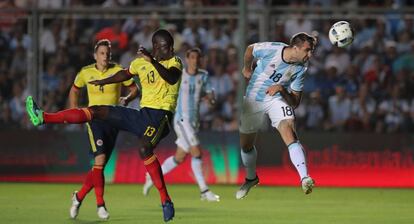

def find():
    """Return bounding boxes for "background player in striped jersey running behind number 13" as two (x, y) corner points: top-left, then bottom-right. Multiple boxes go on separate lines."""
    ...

(143, 48), (220, 201)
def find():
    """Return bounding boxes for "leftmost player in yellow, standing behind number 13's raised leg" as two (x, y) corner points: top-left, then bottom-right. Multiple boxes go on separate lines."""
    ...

(69, 39), (138, 219)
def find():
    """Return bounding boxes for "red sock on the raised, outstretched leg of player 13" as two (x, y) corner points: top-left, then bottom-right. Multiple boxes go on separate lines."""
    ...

(43, 108), (92, 124)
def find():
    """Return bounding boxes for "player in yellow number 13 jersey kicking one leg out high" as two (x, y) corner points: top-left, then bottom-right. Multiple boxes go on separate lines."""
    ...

(26, 29), (182, 222)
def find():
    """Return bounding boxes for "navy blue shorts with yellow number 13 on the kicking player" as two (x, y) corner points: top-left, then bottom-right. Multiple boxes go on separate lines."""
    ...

(105, 106), (173, 147)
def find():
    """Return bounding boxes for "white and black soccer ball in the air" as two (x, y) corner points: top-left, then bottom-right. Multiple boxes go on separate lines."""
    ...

(329, 21), (354, 47)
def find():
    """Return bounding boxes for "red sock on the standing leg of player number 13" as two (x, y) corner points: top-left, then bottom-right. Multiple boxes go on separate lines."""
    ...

(144, 154), (171, 204)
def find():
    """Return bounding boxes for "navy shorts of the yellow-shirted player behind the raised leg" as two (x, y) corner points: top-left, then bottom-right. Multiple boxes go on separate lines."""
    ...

(86, 120), (118, 159)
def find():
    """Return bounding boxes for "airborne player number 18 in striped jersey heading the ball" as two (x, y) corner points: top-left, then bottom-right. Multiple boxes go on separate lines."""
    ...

(236, 33), (316, 199)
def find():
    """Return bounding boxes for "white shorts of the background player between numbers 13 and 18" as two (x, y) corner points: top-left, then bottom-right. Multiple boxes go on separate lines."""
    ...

(174, 119), (200, 153)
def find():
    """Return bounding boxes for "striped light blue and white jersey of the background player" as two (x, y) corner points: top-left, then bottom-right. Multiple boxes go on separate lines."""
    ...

(175, 69), (213, 124)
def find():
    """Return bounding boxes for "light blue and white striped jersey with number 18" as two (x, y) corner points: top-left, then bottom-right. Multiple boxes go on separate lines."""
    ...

(246, 42), (307, 102)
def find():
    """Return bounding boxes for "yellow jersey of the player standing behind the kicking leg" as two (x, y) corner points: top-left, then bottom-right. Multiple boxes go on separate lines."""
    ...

(73, 63), (134, 106)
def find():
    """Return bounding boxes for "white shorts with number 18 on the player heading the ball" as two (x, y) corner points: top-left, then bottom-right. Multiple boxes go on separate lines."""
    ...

(239, 98), (295, 134)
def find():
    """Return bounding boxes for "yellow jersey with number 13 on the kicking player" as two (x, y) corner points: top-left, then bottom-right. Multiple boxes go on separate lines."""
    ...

(128, 56), (183, 112)
